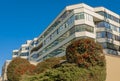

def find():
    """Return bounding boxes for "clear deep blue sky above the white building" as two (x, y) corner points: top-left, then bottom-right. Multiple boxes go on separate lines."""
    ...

(0, 0), (120, 74)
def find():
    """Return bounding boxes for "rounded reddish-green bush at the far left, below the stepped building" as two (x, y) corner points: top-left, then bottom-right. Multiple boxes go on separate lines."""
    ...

(7, 58), (35, 81)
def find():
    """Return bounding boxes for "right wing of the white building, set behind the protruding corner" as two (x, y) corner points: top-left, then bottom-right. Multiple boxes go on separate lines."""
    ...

(94, 7), (120, 55)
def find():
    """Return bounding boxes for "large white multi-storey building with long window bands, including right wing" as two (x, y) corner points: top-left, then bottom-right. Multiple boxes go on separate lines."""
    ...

(29, 3), (120, 62)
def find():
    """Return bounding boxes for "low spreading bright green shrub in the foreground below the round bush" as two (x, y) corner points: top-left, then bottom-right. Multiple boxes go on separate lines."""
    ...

(21, 63), (105, 81)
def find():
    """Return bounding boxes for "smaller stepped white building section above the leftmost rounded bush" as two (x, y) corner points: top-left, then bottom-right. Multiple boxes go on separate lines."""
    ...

(12, 40), (32, 59)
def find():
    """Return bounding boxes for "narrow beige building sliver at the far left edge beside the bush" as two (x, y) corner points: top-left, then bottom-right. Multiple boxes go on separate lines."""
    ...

(1, 60), (11, 81)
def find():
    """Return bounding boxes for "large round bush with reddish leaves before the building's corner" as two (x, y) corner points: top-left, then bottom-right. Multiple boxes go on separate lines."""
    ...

(66, 38), (105, 68)
